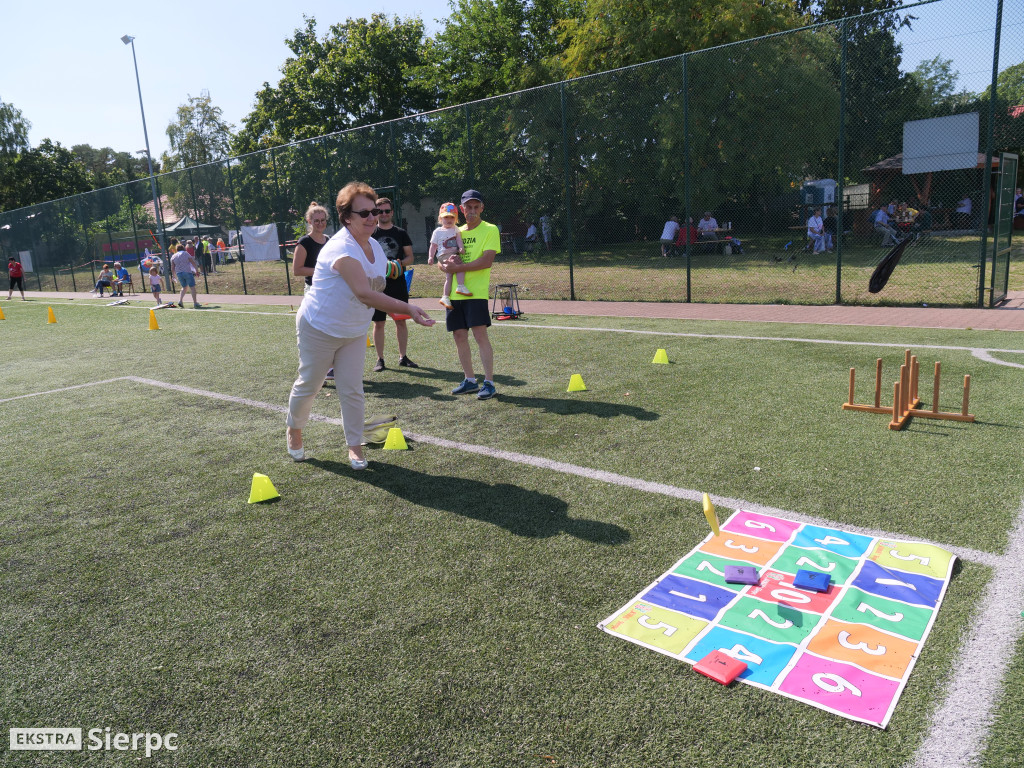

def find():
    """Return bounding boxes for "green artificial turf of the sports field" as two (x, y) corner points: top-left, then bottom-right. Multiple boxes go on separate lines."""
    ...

(0, 301), (1024, 767)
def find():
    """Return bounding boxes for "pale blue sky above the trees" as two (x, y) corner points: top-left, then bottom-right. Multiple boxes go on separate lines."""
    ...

(0, 0), (1024, 163)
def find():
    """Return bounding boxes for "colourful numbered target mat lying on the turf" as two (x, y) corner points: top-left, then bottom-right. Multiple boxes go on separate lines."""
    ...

(598, 510), (956, 728)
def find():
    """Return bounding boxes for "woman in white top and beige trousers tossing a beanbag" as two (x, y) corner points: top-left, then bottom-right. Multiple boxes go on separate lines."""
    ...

(287, 181), (434, 469)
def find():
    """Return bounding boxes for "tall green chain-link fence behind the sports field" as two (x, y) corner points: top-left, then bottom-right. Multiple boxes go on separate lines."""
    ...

(0, 0), (1024, 306)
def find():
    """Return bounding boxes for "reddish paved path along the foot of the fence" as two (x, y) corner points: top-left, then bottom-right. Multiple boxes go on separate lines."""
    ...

(12, 291), (1024, 331)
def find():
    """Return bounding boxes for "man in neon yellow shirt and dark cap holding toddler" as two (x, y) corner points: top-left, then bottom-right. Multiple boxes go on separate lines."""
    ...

(437, 189), (502, 400)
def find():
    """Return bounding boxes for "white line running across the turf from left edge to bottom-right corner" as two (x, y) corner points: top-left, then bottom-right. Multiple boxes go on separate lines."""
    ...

(0, 376), (1024, 768)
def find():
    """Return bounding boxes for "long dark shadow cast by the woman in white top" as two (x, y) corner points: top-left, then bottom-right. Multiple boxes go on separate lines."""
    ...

(306, 459), (630, 546)
